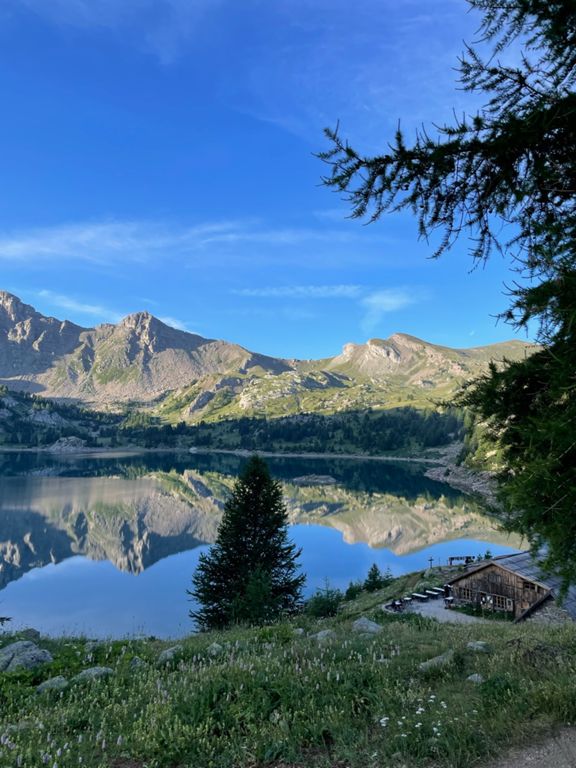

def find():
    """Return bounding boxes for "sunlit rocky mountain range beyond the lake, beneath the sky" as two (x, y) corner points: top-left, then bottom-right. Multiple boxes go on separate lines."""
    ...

(0, 291), (534, 422)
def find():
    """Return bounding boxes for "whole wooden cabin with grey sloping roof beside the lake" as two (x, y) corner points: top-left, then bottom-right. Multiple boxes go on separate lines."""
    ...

(447, 552), (576, 621)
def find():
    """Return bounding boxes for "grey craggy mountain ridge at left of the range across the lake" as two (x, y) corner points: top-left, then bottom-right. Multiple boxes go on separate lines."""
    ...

(0, 292), (291, 405)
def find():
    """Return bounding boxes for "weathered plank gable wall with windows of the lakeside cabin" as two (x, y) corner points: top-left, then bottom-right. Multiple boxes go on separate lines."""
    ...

(452, 565), (549, 618)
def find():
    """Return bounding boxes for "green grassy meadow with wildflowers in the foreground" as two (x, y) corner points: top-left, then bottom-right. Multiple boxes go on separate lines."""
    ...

(0, 574), (576, 768)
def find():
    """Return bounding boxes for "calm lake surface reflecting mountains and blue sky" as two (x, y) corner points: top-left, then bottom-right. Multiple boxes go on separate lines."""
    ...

(0, 452), (521, 638)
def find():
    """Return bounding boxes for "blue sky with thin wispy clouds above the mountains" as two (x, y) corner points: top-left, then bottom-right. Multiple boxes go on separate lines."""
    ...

(0, 0), (524, 358)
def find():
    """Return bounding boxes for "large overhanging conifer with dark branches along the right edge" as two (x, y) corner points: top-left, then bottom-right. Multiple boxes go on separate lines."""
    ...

(320, 0), (576, 586)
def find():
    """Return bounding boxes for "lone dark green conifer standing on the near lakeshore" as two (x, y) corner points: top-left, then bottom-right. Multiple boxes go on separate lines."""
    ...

(188, 456), (305, 629)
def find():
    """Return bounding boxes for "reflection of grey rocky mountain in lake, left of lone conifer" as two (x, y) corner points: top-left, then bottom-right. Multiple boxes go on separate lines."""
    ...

(0, 477), (221, 589)
